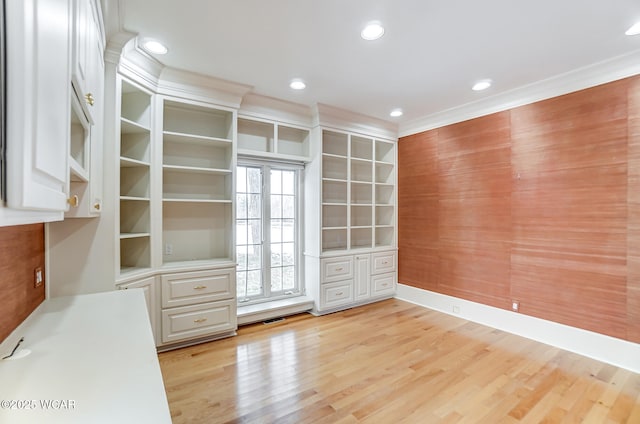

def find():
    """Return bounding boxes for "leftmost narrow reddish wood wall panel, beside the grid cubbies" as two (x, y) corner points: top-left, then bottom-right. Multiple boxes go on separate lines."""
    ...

(398, 131), (440, 290)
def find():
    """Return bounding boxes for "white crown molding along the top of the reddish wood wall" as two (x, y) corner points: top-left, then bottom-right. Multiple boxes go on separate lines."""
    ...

(399, 50), (640, 137)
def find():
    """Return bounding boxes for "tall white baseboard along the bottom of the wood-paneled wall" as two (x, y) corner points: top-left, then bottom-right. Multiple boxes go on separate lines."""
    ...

(396, 284), (640, 373)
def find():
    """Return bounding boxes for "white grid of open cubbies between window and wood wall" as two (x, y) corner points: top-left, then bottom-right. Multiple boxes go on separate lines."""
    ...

(321, 129), (395, 252)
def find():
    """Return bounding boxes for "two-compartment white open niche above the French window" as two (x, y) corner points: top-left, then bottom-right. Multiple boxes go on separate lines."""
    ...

(238, 116), (310, 162)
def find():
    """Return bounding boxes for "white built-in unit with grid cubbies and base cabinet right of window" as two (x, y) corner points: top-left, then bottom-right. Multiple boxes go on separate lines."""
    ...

(305, 107), (397, 314)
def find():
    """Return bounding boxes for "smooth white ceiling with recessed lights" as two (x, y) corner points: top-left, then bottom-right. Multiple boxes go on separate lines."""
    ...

(114, 0), (640, 124)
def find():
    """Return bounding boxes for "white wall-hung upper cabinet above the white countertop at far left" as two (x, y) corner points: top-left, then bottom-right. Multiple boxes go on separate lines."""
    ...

(0, 0), (104, 225)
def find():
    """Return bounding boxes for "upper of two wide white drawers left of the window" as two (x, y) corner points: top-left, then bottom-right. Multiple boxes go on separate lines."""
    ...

(162, 269), (235, 308)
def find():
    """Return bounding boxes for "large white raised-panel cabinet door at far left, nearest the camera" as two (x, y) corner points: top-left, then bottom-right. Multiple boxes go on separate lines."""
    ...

(6, 0), (71, 214)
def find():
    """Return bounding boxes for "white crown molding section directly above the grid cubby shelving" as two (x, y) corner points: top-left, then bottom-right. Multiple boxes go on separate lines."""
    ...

(313, 103), (398, 140)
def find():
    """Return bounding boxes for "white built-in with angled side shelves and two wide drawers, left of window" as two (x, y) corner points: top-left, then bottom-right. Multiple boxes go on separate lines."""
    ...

(116, 75), (237, 350)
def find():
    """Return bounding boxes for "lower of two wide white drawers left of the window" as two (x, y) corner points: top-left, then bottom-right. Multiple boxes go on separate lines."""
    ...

(162, 300), (237, 343)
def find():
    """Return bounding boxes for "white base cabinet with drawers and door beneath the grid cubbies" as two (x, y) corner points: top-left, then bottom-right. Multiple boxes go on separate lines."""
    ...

(309, 250), (397, 315)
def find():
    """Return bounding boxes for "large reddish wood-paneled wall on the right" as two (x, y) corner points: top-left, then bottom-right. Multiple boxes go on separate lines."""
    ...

(398, 77), (640, 342)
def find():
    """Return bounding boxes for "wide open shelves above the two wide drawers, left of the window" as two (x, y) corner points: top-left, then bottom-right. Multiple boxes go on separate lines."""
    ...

(162, 98), (235, 267)
